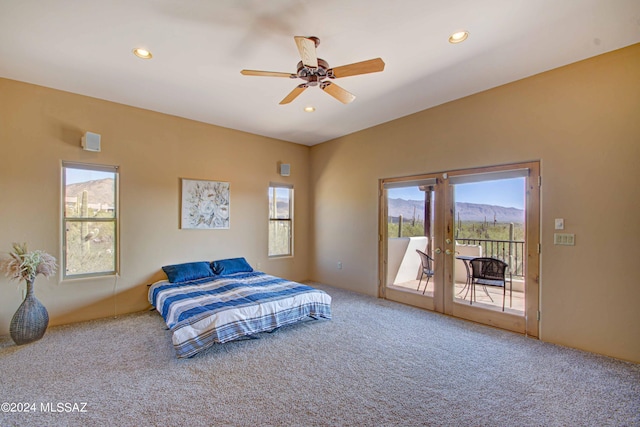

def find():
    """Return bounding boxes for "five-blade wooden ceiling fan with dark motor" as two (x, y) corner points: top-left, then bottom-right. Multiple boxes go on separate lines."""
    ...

(240, 36), (384, 105)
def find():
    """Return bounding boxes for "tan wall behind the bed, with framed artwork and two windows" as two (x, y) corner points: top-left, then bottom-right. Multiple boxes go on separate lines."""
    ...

(0, 79), (310, 334)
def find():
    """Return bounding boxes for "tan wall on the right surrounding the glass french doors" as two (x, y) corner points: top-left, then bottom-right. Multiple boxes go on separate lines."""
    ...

(311, 45), (640, 361)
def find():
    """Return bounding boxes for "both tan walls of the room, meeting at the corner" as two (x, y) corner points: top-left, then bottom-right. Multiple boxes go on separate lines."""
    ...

(0, 45), (640, 361)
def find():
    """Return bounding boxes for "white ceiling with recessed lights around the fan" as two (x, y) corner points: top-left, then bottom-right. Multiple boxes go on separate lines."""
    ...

(0, 0), (640, 145)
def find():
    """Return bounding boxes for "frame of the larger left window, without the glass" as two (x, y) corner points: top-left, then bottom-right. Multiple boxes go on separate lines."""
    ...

(60, 161), (120, 281)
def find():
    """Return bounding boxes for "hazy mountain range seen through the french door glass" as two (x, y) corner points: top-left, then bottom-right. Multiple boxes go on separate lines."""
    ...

(388, 198), (524, 224)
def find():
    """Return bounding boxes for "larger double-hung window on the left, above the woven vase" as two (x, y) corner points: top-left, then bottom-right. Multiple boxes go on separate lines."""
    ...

(62, 162), (118, 279)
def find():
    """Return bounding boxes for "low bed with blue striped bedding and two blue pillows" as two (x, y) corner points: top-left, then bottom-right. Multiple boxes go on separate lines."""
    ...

(149, 258), (331, 358)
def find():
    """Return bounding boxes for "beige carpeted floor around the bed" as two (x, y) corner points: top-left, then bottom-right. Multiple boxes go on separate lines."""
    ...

(0, 285), (640, 427)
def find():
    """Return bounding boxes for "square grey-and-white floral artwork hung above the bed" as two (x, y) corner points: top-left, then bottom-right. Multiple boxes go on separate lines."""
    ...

(181, 179), (229, 229)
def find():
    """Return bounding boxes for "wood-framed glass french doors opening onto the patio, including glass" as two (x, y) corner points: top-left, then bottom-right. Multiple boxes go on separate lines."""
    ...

(379, 162), (540, 337)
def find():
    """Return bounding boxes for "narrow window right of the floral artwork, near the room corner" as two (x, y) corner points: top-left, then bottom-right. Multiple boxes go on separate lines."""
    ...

(269, 184), (293, 257)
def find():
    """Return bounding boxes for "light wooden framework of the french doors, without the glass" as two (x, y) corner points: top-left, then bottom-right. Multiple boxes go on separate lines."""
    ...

(378, 161), (541, 337)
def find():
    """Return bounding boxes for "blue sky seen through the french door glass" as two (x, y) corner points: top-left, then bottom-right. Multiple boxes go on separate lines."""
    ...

(388, 178), (525, 209)
